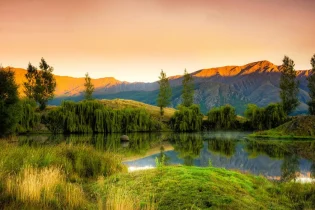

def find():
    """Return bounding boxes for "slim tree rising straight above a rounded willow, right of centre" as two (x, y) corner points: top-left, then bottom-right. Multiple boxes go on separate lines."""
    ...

(182, 69), (194, 107)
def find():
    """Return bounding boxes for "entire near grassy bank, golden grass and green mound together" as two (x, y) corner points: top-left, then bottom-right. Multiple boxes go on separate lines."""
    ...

(0, 140), (315, 209)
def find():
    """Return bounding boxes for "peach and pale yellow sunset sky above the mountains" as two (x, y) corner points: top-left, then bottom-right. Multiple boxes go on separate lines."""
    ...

(0, 0), (315, 82)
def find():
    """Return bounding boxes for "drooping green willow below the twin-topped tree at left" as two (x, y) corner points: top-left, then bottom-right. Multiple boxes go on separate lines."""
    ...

(17, 98), (41, 133)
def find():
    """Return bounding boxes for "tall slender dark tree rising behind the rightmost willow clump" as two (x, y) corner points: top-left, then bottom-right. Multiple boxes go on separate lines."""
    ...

(280, 56), (299, 114)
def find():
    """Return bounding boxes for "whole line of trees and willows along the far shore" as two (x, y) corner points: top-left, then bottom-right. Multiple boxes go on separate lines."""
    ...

(0, 54), (315, 135)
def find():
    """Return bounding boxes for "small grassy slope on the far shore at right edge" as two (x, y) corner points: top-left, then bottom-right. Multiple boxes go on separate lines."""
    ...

(251, 116), (315, 139)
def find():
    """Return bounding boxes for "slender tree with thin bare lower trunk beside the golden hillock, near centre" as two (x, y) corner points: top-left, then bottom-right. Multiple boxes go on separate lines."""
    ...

(157, 70), (172, 118)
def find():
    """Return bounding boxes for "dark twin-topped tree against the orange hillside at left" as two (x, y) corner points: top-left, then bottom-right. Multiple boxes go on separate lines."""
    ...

(24, 58), (56, 110)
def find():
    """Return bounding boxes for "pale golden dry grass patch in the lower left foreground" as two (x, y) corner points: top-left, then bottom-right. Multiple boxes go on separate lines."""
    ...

(5, 166), (86, 209)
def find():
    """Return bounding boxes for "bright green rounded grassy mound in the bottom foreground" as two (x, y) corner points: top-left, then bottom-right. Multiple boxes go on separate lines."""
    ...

(95, 166), (315, 209)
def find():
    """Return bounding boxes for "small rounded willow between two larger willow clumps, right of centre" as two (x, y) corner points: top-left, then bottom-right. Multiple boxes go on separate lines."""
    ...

(207, 105), (236, 129)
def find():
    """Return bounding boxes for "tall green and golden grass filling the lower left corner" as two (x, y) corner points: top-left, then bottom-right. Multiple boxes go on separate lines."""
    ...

(0, 142), (126, 209)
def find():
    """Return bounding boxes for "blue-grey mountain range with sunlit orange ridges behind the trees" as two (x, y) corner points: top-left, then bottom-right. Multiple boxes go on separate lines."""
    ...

(6, 60), (310, 115)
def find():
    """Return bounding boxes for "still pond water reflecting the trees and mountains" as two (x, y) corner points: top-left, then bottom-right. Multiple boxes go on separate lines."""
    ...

(18, 132), (315, 180)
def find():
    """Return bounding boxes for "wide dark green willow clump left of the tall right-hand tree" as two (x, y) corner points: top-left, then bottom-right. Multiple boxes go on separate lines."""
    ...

(245, 104), (286, 130)
